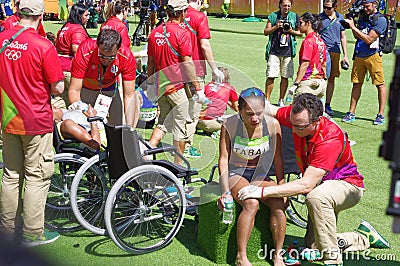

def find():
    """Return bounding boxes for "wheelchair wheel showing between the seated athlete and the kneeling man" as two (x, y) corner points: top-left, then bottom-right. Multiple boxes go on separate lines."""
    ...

(286, 173), (308, 228)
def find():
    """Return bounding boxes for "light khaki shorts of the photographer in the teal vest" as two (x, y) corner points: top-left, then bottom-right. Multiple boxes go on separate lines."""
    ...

(266, 55), (294, 78)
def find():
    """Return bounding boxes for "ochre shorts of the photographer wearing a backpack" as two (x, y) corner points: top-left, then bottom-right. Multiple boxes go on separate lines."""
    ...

(351, 53), (385, 85)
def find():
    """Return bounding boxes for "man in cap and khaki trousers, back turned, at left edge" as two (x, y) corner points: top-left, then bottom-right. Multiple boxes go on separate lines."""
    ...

(0, 0), (64, 246)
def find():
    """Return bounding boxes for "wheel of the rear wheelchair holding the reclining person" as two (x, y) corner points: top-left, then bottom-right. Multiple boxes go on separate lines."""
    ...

(45, 153), (87, 232)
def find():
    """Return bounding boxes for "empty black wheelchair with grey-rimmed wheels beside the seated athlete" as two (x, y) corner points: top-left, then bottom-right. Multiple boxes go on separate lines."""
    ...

(70, 120), (206, 254)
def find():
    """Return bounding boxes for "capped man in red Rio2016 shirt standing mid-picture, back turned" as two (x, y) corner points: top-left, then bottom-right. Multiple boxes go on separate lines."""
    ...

(147, 0), (204, 164)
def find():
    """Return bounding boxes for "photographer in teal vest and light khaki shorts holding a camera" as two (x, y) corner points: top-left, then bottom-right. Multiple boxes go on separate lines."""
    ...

(264, 0), (302, 106)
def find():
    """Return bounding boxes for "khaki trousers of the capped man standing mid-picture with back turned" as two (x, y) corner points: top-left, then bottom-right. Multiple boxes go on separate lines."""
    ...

(157, 89), (193, 141)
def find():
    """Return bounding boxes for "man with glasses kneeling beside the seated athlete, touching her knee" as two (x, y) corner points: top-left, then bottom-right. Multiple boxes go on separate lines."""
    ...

(239, 93), (389, 265)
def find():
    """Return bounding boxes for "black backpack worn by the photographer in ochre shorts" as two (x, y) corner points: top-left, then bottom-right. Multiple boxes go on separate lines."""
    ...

(372, 13), (397, 54)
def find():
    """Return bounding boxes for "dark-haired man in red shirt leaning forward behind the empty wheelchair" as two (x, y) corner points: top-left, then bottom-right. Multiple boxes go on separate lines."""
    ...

(68, 29), (142, 128)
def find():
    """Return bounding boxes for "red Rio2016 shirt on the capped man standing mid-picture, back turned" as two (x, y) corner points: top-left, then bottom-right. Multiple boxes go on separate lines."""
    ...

(147, 22), (192, 94)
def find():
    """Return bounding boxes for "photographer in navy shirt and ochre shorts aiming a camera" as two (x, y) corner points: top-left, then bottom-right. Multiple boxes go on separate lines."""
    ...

(342, 0), (387, 125)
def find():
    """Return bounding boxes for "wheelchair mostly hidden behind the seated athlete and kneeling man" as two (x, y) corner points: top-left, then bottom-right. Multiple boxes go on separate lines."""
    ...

(208, 126), (308, 228)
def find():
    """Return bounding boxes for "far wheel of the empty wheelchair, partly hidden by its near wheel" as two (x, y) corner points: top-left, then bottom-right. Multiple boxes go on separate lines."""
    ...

(71, 155), (108, 235)
